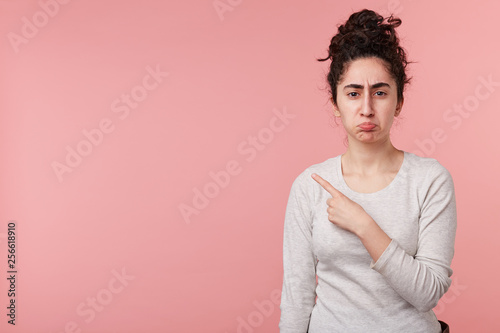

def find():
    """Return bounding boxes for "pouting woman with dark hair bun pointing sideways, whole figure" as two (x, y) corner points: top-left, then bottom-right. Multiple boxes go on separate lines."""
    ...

(279, 9), (457, 333)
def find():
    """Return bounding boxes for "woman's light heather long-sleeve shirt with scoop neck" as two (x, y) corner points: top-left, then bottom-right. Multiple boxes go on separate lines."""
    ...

(279, 152), (457, 333)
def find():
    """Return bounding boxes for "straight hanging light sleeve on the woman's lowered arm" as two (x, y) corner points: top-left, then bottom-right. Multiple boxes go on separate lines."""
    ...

(279, 172), (317, 333)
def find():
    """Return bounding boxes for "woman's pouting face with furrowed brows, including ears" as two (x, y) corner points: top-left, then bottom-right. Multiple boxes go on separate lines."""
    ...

(333, 57), (403, 143)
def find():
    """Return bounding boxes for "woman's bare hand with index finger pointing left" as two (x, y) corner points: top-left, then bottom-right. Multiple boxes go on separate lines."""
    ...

(311, 173), (372, 236)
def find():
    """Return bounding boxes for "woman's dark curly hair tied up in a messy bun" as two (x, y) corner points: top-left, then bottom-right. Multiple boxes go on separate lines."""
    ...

(316, 9), (411, 104)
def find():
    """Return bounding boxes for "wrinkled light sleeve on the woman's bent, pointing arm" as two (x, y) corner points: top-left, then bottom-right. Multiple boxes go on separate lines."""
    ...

(370, 161), (457, 312)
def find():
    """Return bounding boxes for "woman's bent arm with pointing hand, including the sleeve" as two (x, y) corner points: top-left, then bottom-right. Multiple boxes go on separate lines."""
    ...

(313, 161), (457, 312)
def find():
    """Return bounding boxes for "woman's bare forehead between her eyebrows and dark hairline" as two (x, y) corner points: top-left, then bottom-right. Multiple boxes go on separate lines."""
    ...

(339, 57), (394, 84)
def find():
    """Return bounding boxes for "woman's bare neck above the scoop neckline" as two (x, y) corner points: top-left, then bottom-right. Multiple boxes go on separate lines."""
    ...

(342, 138), (403, 175)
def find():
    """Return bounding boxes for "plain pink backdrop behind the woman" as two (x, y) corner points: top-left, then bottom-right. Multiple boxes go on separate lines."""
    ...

(0, 0), (500, 333)
